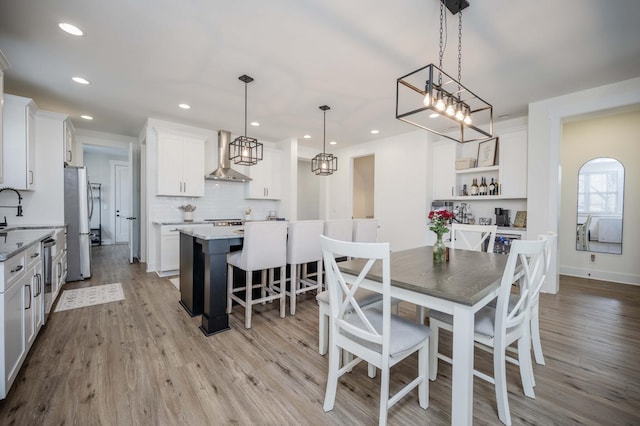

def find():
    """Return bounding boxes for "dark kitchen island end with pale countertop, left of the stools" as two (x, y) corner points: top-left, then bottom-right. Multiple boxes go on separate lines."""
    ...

(180, 225), (242, 336)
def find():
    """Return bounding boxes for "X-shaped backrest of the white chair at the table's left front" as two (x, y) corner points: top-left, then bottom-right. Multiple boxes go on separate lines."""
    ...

(321, 236), (391, 358)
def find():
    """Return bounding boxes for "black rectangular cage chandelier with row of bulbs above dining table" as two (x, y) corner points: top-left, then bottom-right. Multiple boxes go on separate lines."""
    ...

(396, 0), (493, 143)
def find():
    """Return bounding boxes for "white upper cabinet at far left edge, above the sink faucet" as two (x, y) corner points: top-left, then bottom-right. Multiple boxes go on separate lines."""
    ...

(2, 94), (37, 190)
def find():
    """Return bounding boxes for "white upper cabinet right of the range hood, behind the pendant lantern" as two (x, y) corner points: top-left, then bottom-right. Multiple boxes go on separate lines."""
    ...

(245, 148), (282, 200)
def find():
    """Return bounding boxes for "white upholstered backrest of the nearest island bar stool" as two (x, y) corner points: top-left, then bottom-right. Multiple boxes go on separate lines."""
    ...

(240, 221), (287, 271)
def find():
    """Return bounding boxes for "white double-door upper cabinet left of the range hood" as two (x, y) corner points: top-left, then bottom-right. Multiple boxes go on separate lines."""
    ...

(158, 133), (205, 197)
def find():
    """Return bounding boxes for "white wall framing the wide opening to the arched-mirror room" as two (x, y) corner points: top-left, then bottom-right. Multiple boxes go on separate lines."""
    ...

(527, 78), (640, 293)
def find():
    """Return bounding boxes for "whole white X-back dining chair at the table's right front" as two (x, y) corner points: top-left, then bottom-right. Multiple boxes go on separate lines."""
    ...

(429, 240), (546, 425)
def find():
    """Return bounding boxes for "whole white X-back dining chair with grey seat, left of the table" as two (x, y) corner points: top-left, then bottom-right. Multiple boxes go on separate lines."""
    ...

(321, 236), (430, 425)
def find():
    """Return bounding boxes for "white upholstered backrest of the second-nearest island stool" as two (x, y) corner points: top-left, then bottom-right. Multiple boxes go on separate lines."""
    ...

(287, 220), (324, 265)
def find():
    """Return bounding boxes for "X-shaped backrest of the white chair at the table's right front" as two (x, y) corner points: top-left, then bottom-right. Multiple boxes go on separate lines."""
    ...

(495, 240), (546, 348)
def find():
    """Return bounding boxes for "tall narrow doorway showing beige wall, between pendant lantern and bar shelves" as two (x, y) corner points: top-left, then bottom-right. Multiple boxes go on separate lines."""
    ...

(353, 154), (375, 219)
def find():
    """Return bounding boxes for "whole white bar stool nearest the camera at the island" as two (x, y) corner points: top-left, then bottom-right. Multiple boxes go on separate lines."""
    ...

(227, 221), (287, 328)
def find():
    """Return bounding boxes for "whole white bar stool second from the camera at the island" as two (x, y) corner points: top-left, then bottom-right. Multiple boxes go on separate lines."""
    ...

(286, 220), (324, 315)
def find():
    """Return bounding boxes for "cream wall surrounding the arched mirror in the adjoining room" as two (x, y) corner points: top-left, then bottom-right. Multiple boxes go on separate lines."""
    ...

(558, 111), (640, 284)
